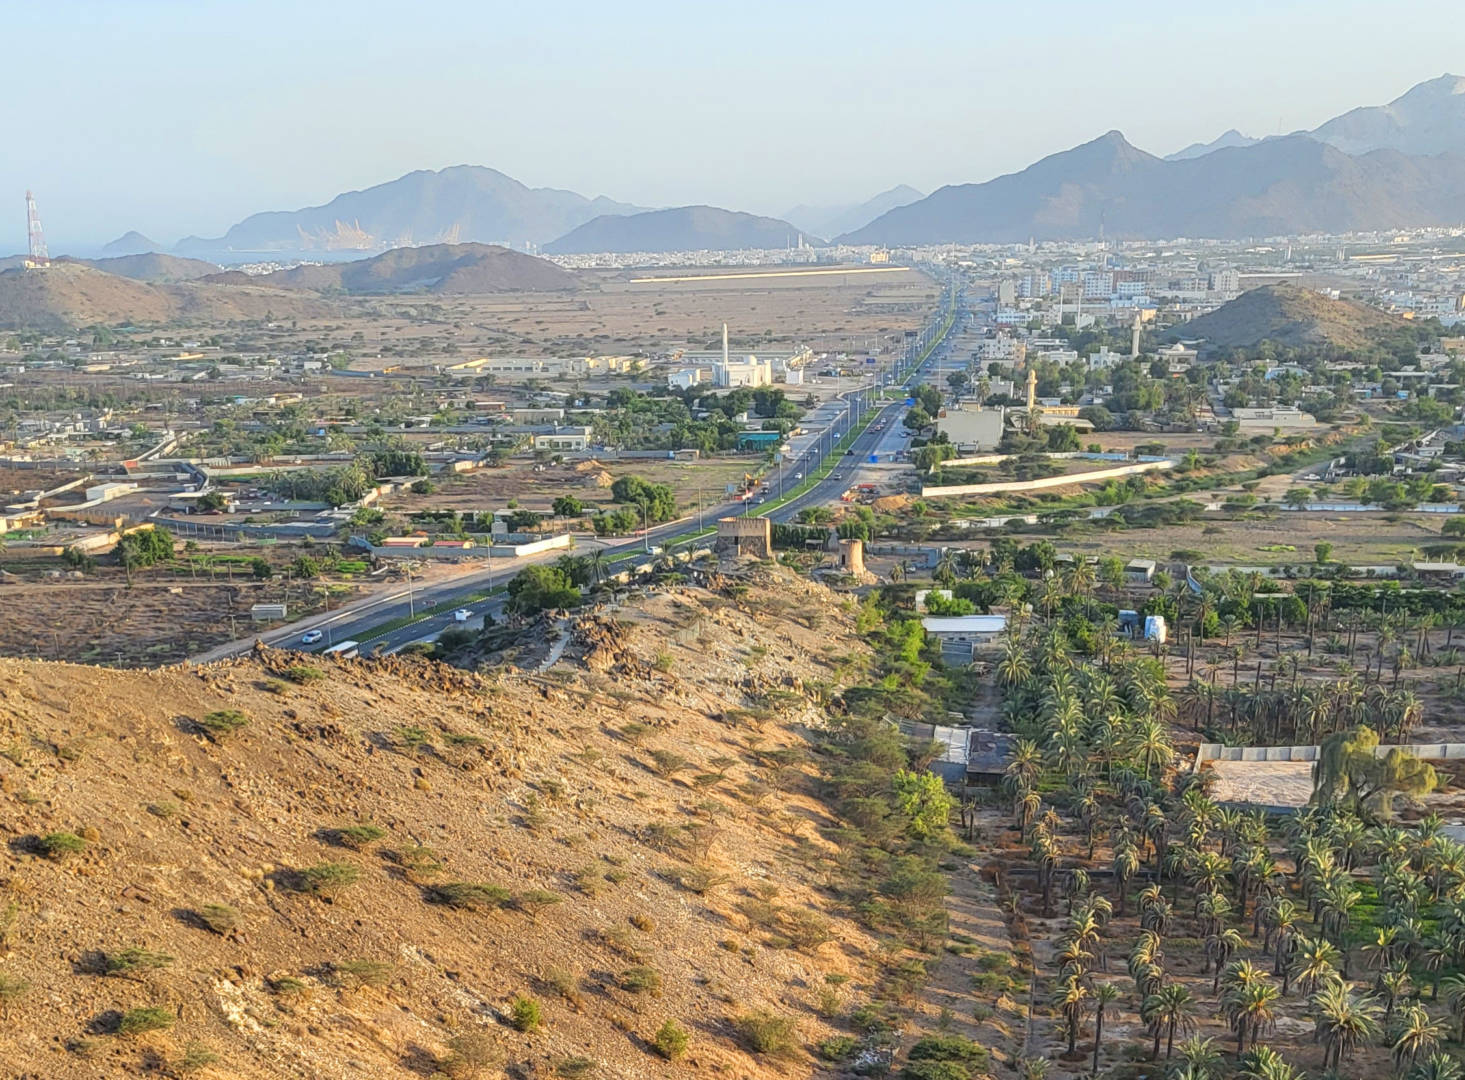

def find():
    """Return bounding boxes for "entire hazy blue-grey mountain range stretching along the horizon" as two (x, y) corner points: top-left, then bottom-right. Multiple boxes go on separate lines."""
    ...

(31, 75), (1465, 261)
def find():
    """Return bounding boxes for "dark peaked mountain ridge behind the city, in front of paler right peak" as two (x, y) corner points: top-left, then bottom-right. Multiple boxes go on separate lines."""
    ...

(839, 132), (1465, 245)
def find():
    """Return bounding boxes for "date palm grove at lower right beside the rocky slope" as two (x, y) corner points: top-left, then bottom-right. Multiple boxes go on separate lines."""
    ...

(996, 595), (1465, 1080)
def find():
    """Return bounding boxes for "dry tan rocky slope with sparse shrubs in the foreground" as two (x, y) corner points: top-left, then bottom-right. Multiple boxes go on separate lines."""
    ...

(0, 572), (875, 1080)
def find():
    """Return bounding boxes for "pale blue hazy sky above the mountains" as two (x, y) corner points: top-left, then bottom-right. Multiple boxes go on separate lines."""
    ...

(0, 0), (1465, 254)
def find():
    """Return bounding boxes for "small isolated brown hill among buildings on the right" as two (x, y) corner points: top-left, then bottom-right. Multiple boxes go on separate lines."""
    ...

(1171, 283), (1405, 349)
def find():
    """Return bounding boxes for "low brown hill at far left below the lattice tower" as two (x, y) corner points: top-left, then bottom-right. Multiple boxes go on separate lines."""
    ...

(0, 262), (331, 331)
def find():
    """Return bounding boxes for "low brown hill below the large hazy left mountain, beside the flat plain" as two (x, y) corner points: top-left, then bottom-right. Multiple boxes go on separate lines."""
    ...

(208, 243), (576, 296)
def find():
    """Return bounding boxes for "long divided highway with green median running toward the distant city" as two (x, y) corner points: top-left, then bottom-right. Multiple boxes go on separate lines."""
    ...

(192, 282), (961, 662)
